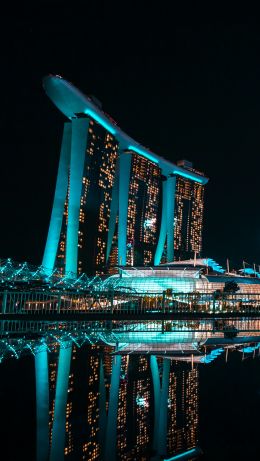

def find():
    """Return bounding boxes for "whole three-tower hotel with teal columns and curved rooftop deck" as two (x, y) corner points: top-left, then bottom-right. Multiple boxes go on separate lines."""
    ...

(43, 75), (208, 274)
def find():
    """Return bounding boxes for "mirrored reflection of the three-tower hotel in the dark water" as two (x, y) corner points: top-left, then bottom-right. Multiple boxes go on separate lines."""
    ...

(44, 344), (198, 461)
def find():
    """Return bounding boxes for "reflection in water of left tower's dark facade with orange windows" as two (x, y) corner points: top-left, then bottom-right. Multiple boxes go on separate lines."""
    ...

(49, 344), (101, 461)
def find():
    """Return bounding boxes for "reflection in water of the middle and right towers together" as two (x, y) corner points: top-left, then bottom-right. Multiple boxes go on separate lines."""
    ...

(104, 354), (198, 461)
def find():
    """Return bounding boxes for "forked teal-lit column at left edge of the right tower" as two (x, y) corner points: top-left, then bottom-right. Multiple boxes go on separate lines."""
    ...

(154, 175), (176, 266)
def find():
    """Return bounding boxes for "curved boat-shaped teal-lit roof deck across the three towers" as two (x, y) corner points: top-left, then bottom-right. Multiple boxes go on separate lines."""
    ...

(43, 75), (208, 184)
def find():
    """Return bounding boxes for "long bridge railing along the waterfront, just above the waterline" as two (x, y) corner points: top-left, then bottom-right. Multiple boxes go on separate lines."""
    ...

(0, 291), (260, 314)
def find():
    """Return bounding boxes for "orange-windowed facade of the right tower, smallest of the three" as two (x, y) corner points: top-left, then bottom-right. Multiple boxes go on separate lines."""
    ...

(174, 160), (204, 260)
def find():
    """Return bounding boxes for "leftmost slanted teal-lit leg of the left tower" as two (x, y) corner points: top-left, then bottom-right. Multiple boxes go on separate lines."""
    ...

(42, 122), (71, 271)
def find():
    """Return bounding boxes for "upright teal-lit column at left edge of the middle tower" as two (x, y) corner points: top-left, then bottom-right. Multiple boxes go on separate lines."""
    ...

(118, 150), (132, 266)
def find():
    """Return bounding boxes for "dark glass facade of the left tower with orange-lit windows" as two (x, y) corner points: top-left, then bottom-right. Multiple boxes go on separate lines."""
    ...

(57, 120), (118, 274)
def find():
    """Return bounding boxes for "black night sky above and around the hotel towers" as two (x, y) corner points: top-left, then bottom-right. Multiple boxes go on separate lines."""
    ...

(0, 1), (260, 267)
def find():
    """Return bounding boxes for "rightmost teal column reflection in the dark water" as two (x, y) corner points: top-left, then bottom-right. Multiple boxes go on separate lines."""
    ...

(158, 359), (171, 456)
